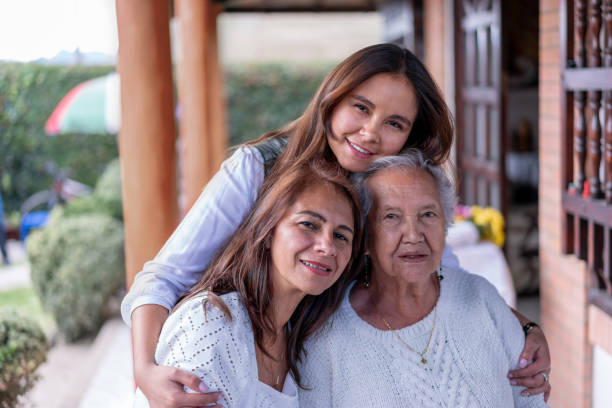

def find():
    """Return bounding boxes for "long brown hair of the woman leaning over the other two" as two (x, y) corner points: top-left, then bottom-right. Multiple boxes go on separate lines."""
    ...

(249, 44), (454, 172)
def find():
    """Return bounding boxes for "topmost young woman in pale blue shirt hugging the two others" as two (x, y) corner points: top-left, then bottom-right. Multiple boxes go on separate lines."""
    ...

(122, 44), (550, 407)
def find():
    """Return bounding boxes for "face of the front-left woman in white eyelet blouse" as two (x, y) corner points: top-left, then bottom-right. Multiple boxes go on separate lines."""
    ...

(270, 183), (354, 295)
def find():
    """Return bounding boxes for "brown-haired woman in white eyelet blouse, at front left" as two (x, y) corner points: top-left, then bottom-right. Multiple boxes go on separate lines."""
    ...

(135, 162), (361, 408)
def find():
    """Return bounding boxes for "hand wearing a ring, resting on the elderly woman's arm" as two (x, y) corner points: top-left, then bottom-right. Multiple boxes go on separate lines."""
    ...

(508, 327), (551, 401)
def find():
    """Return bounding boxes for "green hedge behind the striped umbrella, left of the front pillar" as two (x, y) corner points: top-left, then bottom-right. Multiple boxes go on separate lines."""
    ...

(0, 63), (117, 214)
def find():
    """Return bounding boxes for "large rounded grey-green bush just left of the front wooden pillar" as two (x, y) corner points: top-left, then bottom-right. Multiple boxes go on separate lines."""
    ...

(27, 214), (125, 341)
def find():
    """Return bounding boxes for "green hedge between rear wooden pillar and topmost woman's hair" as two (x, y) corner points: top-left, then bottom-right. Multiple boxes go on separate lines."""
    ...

(225, 64), (332, 145)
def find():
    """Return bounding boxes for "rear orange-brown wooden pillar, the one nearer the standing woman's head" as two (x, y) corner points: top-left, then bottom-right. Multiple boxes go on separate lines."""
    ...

(175, 0), (227, 211)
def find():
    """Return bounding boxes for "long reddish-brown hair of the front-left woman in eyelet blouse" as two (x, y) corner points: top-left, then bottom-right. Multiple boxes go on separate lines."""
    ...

(177, 160), (362, 386)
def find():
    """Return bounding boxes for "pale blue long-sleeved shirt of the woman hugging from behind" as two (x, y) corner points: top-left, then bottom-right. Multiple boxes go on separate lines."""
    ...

(121, 146), (459, 326)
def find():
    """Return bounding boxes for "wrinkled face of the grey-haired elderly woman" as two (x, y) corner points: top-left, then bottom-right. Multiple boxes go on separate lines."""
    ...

(367, 169), (445, 283)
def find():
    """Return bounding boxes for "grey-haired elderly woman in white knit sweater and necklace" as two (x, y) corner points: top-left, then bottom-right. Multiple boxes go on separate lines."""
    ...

(300, 150), (548, 408)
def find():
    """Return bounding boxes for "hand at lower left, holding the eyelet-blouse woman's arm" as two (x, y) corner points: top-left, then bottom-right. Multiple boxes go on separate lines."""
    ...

(134, 364), (221, 408)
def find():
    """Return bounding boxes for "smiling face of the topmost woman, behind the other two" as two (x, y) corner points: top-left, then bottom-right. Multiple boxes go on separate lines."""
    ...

(327, 74), (418, 173)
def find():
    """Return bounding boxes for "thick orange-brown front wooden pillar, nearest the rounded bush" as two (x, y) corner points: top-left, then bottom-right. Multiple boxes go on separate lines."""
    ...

(117, 0), (178, 287)
